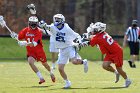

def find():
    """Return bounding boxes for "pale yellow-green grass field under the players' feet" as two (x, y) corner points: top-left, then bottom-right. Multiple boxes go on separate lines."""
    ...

(0, 61), (140, 93)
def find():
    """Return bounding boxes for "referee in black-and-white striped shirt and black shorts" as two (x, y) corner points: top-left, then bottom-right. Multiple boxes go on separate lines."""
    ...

(123, 20), (139, 68)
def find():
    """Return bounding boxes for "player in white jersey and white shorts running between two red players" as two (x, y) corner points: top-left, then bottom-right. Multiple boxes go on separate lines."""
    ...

(40, 14), (88, 88)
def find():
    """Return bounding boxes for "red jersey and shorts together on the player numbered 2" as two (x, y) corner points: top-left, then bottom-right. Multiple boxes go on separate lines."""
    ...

(90, 32), (123, 67)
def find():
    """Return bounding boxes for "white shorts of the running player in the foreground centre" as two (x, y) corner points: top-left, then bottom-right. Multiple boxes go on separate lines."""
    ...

(57, 46), (81, 64)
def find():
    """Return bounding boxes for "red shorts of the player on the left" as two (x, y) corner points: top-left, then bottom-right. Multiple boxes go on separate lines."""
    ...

(27, 48), (47, 63)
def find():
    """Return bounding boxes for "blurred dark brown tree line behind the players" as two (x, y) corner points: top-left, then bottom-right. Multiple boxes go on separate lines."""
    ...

(0, 0), (140, 35)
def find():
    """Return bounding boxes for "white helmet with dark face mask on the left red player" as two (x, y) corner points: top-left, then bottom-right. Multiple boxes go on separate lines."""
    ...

(28, 16), (38, 29)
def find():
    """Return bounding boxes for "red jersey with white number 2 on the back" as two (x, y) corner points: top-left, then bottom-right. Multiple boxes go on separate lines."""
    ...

(90, 32), (122, 54)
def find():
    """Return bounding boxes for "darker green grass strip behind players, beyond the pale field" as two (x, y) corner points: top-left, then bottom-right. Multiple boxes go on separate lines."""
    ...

(0, 38), (129, 60)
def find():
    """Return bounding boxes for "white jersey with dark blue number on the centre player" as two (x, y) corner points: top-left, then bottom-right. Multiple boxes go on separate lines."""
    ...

(48, 23), (80, 49)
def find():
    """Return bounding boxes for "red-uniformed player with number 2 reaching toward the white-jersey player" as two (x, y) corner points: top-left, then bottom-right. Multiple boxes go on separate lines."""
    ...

(80, 22), (131, 87)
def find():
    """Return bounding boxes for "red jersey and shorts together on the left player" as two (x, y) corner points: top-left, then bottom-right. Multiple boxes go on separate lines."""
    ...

(18, 27), (46, 62)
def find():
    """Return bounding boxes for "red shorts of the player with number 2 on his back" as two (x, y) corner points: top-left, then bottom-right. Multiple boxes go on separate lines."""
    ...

(104, 51), (123, 67)
